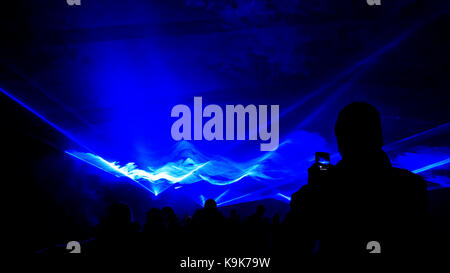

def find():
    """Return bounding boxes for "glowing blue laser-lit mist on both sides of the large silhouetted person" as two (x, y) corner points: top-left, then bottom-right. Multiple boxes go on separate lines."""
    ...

(66, 130), (449, 204)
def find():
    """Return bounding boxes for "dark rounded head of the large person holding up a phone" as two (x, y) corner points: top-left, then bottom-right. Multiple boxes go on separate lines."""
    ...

(334, 102), (383, 159)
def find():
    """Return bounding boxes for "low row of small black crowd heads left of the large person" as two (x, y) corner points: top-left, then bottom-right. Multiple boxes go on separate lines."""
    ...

(83, 199), (281, 259)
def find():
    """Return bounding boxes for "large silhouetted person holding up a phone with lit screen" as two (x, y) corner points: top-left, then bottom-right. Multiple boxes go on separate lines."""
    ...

(285, 102), (428, 256)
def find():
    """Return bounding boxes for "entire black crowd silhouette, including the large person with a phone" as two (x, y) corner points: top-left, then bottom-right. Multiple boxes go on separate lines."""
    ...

(38, 102), (440, 264)
